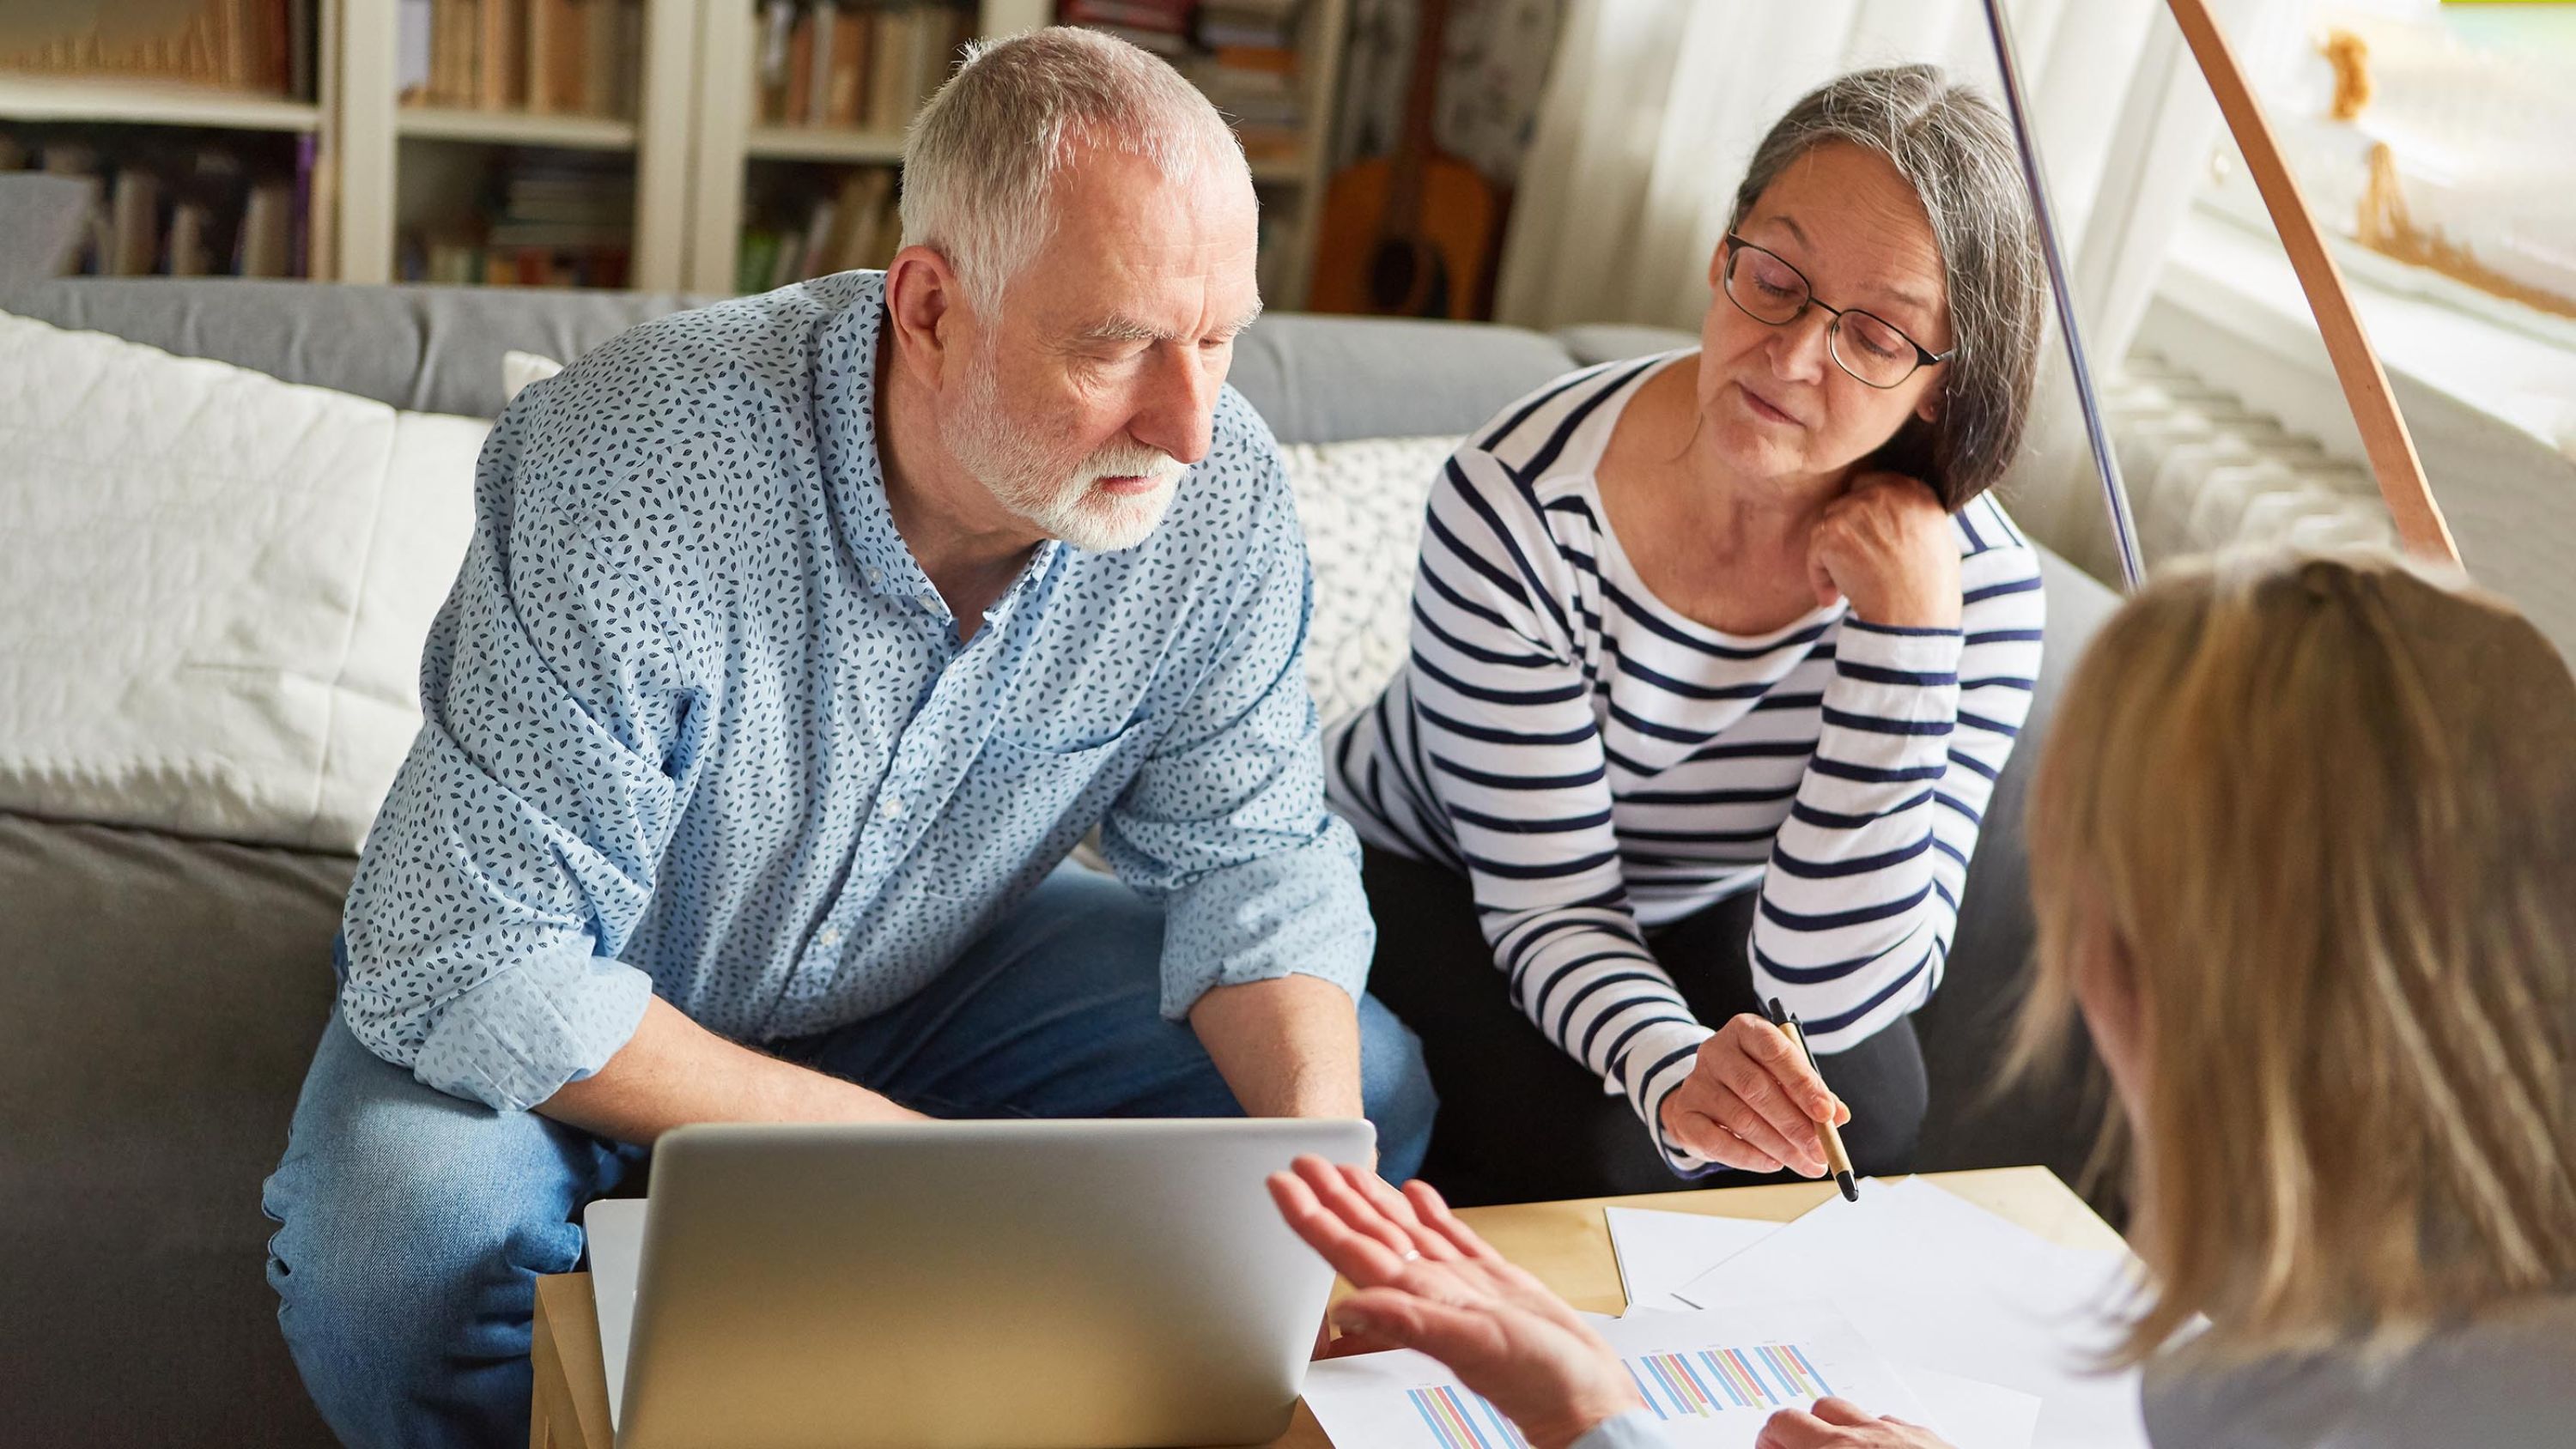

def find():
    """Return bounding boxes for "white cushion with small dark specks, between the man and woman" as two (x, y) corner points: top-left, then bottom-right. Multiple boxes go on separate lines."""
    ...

(1280, 438), (1458, 724)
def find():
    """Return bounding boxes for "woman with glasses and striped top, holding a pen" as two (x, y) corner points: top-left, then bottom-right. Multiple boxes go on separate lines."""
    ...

(1324, 64), (2045, 1199)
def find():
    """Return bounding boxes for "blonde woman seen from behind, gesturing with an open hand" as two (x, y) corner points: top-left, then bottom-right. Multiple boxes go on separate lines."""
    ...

(1273, 556), (2576, 1449)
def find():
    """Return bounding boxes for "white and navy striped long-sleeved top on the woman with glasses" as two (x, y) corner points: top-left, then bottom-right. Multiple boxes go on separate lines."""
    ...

(1324, 353), (2043, 1176)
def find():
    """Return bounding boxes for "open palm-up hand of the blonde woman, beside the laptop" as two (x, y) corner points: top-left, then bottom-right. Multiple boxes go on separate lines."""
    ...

(1270, 1155), (1646, 1449)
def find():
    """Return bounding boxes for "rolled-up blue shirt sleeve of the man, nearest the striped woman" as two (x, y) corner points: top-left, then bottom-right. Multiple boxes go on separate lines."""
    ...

(1100, 452), (1376, 1019)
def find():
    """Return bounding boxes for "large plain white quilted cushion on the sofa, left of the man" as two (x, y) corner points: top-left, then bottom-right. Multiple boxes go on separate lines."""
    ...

(0, 314), (489, 849)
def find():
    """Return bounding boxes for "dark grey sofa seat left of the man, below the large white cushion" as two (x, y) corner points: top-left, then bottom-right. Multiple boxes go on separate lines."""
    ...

(0, 813), (353, 1446)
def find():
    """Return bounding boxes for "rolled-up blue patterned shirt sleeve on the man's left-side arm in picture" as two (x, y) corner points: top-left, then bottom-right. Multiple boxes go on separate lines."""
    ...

(340, 386), (703, 1112)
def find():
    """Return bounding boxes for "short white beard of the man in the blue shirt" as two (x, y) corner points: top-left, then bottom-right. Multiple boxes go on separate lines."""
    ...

(940, 358), (1188, 554)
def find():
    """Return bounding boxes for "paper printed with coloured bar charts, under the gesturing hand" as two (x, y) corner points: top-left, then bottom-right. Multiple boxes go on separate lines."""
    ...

(1306, 1305), (1924, 1449)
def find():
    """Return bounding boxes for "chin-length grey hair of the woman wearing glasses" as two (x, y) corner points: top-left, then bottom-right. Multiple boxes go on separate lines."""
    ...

(1728, 64), (2048, 512)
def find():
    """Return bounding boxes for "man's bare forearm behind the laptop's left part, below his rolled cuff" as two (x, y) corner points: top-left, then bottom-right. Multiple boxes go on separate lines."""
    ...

(536, 996), (925, 1143)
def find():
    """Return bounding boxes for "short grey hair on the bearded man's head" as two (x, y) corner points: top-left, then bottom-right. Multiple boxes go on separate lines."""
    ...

(902, 26), (1242, 317)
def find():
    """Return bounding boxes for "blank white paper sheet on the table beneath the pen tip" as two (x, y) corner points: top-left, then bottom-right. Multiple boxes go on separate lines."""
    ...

(1680, 1179), (2146, 1449)
